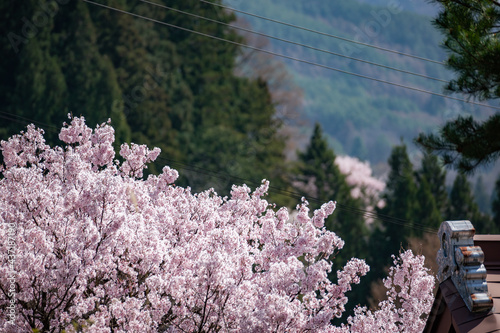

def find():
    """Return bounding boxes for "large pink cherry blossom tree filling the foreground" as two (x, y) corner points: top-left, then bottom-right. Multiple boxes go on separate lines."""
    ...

(0, 117), (433, 332)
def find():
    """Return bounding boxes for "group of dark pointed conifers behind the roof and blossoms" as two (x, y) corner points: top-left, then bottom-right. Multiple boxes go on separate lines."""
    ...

(294, 124), (500, 316)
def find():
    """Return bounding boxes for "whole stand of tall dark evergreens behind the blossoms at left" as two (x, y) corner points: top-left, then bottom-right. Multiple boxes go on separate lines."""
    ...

(0, 0), (294, 202)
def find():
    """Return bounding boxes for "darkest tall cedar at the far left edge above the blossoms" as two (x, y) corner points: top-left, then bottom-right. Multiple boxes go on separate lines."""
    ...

(0, 1), (66, 139)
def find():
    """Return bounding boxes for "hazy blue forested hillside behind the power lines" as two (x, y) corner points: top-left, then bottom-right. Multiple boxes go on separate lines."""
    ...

(225, 0), (491, 164)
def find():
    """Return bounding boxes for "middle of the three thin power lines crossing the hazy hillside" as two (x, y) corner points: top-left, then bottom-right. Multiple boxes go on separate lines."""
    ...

(140, 0), (448, 83)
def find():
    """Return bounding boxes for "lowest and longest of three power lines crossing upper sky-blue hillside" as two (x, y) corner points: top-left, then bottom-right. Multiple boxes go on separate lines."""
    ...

(82, 0), (500, 110)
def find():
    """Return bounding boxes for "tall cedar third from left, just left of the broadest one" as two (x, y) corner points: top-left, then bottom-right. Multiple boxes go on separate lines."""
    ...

(91, 1), (193, 166)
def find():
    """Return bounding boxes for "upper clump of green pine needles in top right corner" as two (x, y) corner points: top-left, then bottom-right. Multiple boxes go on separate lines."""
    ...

(435, 0), (500, 99)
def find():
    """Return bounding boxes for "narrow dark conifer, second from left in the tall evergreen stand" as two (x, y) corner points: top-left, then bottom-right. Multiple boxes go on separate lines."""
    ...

(51, 1), (130, 142)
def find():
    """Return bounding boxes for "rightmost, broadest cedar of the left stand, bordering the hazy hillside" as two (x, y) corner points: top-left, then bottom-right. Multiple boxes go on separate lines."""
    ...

(146, 0), (286, 199)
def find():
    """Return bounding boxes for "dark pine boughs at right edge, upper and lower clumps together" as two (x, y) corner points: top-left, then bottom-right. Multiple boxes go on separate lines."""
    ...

(416, 0), (500, 172)
